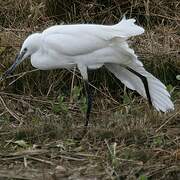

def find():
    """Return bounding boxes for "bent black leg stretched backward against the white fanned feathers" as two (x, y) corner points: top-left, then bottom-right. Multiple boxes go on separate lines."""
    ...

(126, 67), (152, 106)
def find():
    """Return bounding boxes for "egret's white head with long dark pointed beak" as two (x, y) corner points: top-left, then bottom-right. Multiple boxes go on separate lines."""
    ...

(1, 33), (41, 79)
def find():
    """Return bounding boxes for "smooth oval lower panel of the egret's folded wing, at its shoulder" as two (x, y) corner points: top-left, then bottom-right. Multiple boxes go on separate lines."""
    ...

(43, 33), (108, 56)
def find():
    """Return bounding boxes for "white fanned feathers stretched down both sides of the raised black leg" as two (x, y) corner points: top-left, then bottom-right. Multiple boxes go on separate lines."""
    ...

(105, 63), (174, 112)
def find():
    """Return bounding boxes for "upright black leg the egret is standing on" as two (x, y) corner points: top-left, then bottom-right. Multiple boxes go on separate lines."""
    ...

(84, 81), (92, 127)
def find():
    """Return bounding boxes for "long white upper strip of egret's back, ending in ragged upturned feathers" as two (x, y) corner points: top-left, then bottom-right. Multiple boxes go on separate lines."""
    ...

(43, 18), (144, 40)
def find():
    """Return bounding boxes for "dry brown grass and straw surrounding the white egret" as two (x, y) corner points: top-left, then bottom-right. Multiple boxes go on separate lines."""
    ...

(0, 0), (180, 180)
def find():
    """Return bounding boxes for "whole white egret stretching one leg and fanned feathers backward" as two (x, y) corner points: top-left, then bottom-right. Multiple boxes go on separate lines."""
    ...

(2, 18), (174, 126)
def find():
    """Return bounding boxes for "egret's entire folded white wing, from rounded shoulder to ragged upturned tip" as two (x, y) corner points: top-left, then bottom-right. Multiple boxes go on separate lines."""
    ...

(42, 19), (144, 56)
